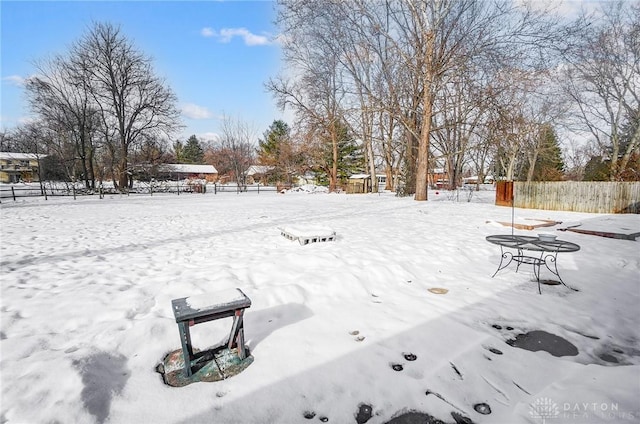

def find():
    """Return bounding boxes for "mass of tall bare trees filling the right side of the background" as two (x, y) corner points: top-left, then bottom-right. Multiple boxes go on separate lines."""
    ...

(267, 0), (640, 200)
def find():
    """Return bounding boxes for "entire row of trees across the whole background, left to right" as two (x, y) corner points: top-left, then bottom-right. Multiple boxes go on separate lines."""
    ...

(0, 0), (640, 200)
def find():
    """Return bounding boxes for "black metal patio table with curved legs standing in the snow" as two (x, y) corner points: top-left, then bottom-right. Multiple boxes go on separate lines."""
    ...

(487, 234), (580, 294)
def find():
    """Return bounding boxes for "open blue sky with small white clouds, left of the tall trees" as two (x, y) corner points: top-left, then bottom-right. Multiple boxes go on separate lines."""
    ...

(0, 0), (284, 143)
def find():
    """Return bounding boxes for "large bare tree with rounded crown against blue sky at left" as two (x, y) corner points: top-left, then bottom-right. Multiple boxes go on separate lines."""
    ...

(71, 23), (179, 189)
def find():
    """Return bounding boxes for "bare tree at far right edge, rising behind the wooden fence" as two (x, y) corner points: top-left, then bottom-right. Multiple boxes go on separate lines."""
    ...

(566, 1), (640, 180)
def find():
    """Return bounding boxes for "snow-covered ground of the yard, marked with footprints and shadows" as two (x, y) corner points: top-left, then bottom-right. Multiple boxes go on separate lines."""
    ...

(0, 192), (640, 424)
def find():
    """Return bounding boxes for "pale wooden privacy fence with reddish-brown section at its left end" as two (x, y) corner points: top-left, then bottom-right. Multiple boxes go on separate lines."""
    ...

(496, 181), (640, 213)
